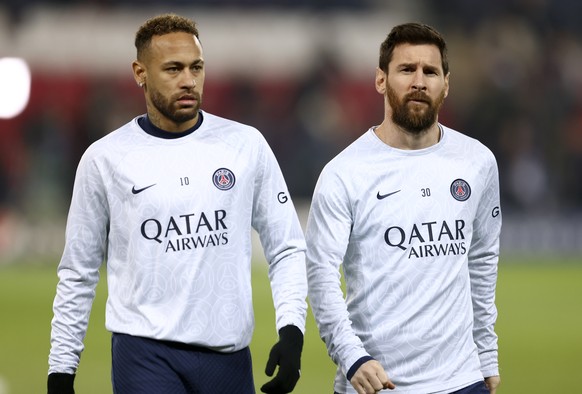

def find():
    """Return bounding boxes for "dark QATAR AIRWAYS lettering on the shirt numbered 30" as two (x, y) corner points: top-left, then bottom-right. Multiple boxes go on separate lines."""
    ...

(384, 219), (467, 259)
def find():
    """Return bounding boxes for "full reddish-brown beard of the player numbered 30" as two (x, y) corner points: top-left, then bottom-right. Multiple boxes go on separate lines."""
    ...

(386, 83), (445, 134)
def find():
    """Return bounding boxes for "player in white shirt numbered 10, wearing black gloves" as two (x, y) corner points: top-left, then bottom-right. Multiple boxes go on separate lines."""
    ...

(48, 14), (307, 394)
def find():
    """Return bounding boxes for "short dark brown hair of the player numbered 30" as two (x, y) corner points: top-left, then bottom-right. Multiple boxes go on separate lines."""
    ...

(378, 22), (449, 75)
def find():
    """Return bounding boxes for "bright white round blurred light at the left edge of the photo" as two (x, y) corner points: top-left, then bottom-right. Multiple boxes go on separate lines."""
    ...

(0, 57), (31, 119)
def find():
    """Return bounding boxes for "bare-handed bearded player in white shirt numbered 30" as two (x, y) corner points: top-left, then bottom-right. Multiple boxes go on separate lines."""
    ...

(306, 23), (501, 394)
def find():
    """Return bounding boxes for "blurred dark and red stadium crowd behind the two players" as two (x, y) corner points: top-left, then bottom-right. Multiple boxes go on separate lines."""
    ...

(0, 0), (582, 258)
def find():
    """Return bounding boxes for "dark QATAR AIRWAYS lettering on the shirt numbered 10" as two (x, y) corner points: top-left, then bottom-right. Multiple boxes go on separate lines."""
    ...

(140, 209), (228, 253)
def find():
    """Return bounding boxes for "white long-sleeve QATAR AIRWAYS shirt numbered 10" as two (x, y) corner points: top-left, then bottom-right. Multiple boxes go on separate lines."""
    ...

(49, 112), (307, 373)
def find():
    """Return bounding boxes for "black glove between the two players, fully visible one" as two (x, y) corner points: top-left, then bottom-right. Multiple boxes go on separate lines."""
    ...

(261, 325), (303, 394)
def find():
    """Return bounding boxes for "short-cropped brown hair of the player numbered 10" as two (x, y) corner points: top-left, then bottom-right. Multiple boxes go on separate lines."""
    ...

(135, 14), (199, 59)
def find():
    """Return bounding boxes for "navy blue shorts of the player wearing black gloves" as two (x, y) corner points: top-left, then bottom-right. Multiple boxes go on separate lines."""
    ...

(111, 334), (255, 394)
